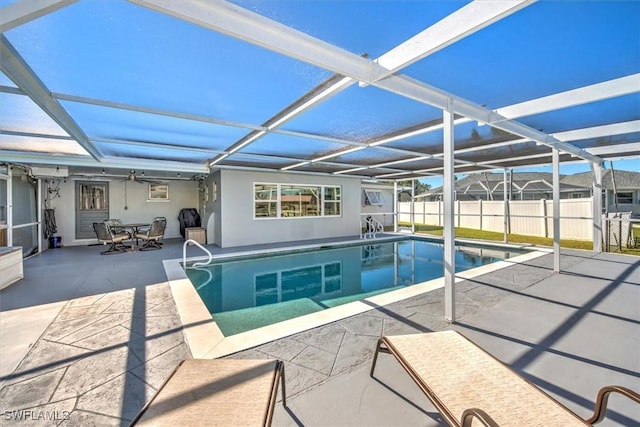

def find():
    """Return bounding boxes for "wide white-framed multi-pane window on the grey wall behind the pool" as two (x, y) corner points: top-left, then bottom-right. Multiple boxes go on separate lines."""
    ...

(253, 183), (342, 218)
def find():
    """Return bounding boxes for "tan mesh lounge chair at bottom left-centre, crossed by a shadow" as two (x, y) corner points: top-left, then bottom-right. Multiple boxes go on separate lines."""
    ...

(131, 359), (286, 427)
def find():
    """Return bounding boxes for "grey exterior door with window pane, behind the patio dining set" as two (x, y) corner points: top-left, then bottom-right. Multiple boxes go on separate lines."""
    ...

(76, 181), (109, 239)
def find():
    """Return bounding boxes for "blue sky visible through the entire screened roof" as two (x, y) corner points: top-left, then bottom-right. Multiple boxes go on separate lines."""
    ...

(0, 0), (640, 176)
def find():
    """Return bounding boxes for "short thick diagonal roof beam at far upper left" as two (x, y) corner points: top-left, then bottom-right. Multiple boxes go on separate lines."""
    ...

(0, 35), (102, 160)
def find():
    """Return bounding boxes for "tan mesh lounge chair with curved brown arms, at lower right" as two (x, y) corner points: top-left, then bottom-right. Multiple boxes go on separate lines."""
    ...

(370, 331), (640, 426)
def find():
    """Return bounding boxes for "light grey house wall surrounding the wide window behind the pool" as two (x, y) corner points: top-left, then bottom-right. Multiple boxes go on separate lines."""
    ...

(215, 170), (361, 247)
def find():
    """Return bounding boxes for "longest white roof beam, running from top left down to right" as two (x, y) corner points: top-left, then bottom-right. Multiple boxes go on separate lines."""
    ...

(130, 0), (602, 164)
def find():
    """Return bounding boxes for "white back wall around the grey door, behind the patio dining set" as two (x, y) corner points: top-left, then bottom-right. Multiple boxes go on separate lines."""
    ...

(43, 180), (199, 248)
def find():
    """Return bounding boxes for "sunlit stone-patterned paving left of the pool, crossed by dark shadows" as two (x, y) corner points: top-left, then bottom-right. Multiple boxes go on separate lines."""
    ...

(0, 284), (190, 426)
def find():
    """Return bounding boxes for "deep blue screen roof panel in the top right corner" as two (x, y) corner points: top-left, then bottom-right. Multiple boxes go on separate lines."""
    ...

(404, 1), (640, 109)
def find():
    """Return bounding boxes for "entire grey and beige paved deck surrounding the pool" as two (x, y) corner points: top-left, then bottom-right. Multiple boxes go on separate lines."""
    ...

(0, 236), (640, 426)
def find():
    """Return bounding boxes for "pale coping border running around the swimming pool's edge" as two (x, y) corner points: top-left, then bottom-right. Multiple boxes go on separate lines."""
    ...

(163, 234), (551, 359)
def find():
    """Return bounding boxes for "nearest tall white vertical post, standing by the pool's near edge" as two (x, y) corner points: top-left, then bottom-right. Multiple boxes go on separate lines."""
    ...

(442, 105), (456, 323)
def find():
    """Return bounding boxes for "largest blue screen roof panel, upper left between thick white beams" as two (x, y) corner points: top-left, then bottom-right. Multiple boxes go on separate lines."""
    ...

(5, 1), (330, 152)
